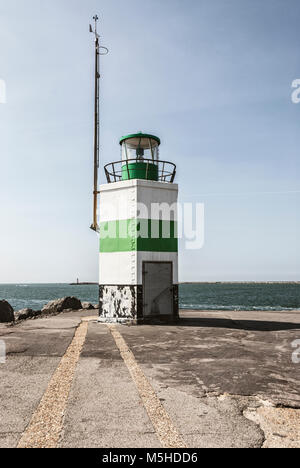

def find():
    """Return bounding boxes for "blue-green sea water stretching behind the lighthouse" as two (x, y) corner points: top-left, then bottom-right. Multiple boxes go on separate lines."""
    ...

(0, 281), (300, 311)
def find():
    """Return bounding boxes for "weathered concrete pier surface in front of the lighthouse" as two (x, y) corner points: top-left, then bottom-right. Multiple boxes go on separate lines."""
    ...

(0, 311), (300, 448)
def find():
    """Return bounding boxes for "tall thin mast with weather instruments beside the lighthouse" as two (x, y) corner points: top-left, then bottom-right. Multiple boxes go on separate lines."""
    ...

(90, 15), (108, 232)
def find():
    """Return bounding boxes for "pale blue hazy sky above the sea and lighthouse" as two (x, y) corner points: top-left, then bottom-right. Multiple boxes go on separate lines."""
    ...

(0, 0), (300, 283)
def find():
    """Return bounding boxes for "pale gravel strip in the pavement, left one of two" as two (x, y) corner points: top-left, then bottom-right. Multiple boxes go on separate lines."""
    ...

(18, 317), (95, 448)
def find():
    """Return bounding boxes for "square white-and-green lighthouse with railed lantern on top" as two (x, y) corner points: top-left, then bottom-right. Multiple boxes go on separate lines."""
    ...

(99, 133), (179, 324)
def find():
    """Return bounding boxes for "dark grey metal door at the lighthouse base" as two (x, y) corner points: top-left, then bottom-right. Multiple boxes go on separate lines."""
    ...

(143, 262), (173, 317)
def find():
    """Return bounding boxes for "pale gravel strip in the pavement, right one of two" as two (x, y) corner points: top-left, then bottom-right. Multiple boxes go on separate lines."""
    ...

(107, 325), (187, 448)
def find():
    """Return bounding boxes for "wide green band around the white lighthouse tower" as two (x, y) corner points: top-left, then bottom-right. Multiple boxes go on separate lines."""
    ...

(100, 219), (178, 253)
